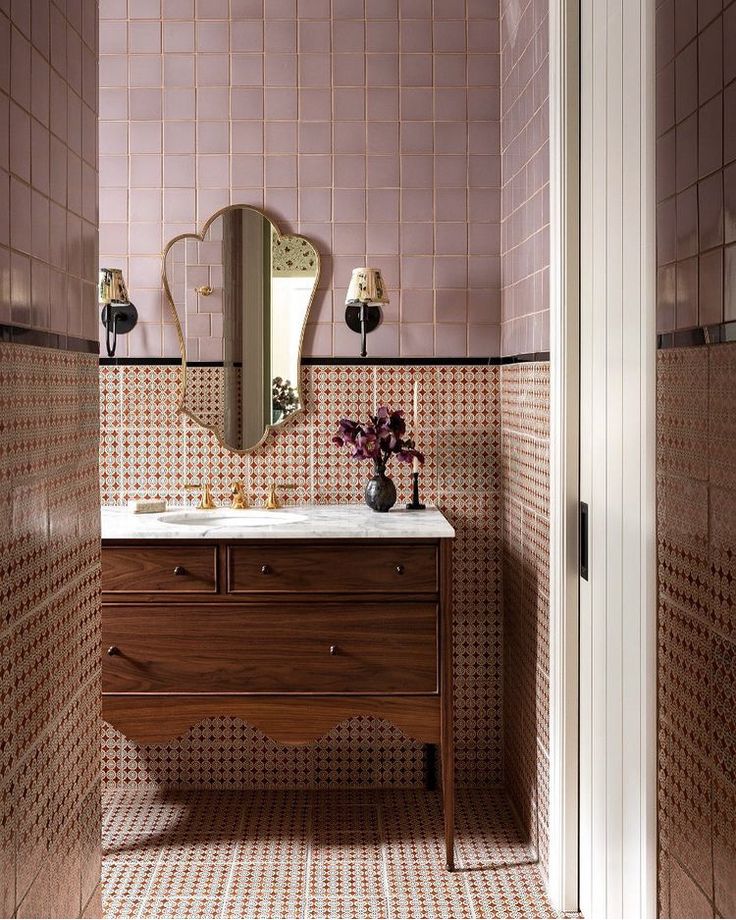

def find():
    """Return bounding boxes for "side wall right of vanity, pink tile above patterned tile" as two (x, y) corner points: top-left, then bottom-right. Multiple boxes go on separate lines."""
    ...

(499, 0), (550, 875)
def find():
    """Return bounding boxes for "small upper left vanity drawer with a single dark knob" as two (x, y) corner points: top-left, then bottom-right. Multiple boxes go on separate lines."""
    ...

(102, 545), (217, 594)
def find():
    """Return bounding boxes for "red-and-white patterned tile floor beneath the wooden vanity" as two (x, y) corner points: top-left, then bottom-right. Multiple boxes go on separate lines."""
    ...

(102, 789), (554, 918)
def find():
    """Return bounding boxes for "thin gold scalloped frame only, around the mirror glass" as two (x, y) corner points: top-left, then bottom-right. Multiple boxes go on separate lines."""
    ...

(161, 204), (321, 456)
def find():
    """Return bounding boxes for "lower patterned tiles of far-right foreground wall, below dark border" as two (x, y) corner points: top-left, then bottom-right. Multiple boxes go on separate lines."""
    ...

(657, 344), (736, 916)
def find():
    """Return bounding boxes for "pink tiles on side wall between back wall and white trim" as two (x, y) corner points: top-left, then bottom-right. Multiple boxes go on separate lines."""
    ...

(501, 0), (550, 355)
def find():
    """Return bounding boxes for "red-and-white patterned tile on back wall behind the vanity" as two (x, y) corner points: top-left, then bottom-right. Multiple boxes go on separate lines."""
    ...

(100, 365), (503, 788)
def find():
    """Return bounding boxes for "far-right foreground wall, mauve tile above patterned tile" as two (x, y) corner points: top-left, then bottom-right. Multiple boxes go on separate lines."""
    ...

(656, 7), (736, 917)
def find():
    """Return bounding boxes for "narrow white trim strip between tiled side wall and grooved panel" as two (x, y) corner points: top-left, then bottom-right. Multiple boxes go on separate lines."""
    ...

(549, 0), (580, 912)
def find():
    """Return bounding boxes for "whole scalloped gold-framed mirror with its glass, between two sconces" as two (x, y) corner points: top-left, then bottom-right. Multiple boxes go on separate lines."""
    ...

(163, 205), (319, 453)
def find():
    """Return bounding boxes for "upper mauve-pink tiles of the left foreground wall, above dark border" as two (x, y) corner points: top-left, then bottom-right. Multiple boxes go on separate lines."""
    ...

(0, 0), (98, 339)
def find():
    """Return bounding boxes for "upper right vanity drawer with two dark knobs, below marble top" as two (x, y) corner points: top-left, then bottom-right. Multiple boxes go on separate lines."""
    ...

(228, 541), (437, 595)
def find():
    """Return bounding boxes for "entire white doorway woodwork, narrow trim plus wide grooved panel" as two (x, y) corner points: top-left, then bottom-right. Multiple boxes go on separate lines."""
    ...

(549, 0), (656, 918)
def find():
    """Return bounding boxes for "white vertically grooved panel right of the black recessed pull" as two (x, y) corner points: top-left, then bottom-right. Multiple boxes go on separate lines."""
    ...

(580, 0), (657, 918)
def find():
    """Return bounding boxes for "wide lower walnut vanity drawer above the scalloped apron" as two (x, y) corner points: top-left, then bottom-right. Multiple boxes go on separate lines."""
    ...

(102, 603), (437, 694)
